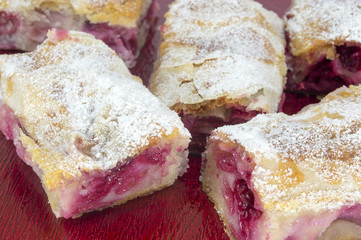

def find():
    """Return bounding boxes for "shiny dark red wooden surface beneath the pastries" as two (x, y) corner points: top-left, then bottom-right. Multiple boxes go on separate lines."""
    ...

(0, 0), (290, 239)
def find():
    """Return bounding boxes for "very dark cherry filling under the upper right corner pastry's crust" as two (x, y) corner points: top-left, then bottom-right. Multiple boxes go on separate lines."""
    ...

(287, 45), (361, 94)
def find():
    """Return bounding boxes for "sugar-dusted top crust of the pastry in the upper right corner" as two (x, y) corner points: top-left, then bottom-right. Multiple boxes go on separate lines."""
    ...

(286, 0), (361, 56)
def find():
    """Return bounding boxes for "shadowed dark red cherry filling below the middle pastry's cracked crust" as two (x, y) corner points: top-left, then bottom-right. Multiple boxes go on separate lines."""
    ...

(179, 107), (261, 152)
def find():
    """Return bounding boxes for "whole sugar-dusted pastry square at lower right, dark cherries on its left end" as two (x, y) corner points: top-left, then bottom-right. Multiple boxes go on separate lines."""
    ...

(201, 86), (361, 240)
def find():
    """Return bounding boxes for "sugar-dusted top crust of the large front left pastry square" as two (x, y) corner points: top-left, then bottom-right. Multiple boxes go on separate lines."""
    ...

(0, 31), (189, 189)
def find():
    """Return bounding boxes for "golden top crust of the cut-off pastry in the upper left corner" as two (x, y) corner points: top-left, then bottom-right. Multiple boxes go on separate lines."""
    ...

(0, 0), (151, 27)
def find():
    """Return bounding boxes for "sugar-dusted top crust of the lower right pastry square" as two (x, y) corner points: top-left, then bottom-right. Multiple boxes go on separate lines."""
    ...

(212, 86), (361, 218)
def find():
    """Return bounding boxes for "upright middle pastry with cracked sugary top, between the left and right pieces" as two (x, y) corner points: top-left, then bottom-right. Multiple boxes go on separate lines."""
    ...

(150, 0), (287, 149)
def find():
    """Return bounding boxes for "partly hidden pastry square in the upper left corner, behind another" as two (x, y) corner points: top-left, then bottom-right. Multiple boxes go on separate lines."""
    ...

(0, 0), (157, 67)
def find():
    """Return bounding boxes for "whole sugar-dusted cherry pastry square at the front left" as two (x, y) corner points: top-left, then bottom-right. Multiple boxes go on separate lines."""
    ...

(0, 31), (190, 218)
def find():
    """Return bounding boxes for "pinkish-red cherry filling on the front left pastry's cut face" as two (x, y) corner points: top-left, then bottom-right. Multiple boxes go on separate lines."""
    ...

(63, 145), (171, 218)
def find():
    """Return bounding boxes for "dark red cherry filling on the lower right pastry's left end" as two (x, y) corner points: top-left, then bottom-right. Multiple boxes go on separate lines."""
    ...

(216, 145), (262, 239)
